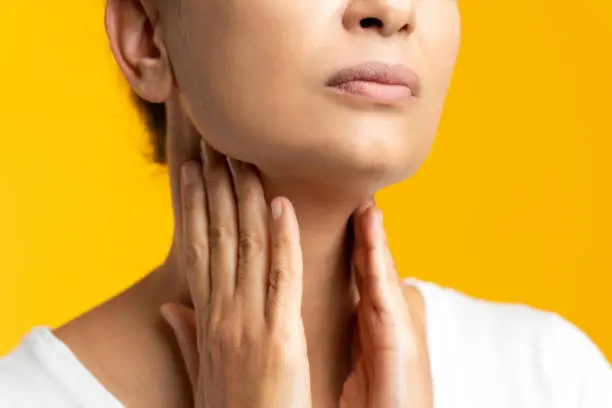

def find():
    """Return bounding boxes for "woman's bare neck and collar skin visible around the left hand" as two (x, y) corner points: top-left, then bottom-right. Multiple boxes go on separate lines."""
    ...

(56, 106), (368, 408)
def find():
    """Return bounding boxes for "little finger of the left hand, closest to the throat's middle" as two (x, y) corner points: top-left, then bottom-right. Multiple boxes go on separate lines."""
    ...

(266, 197), (302, 325)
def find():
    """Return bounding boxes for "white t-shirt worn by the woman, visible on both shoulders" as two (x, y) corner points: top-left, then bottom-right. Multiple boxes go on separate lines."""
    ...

(0, 280), (612, 408)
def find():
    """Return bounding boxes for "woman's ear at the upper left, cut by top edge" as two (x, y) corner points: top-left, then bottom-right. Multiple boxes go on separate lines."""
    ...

(105, 0), (174, 103)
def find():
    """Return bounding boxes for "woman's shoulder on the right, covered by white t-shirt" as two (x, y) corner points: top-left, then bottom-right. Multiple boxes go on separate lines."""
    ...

(407, 280), (612, 408)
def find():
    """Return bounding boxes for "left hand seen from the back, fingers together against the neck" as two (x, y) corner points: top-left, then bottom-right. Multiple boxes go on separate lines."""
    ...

(162, 145), (311, 408)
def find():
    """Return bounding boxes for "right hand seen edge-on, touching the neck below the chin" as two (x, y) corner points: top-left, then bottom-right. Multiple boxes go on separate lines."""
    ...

(340, 204), (433, 408)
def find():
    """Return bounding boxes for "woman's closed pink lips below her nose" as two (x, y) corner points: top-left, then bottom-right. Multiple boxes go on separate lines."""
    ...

(326, 62), (421, 103)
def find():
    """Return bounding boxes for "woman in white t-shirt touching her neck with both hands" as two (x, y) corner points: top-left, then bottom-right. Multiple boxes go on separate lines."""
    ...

(0, 0), (612, 408)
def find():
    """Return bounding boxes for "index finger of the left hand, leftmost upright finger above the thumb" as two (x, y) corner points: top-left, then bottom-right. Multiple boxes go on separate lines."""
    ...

(181, 162), (210, 310)
